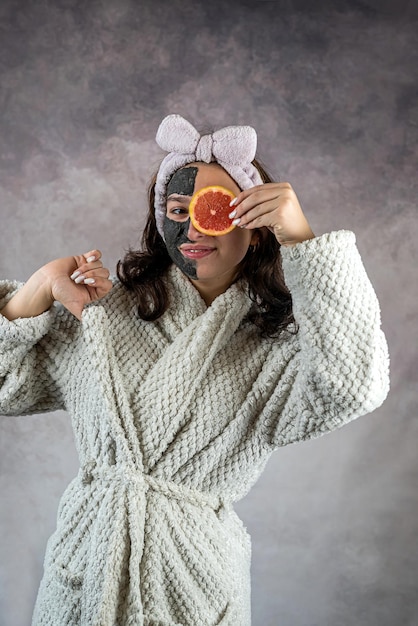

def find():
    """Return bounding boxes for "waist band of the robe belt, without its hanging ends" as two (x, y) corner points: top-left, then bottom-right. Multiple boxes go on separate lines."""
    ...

(80, 461), (231, 517)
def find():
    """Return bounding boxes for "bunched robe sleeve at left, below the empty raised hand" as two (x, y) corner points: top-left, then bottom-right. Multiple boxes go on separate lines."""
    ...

(0, 281), (78, 415)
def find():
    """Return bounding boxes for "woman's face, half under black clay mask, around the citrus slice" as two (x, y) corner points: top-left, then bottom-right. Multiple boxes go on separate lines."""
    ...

(164, 163), (255, 304)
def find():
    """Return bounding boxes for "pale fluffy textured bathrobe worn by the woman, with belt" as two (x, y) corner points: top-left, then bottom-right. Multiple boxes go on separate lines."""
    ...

(0, 231), (388, 626)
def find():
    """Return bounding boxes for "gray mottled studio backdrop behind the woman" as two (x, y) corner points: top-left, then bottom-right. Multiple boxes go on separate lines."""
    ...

(0, 0), (418, 626)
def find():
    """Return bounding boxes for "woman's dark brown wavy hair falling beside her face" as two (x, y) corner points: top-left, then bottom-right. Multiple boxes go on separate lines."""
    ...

(117, 159), (296, 337)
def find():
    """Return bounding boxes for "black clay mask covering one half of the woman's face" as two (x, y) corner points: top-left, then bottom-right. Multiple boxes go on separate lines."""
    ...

(164, 167), (198, 279)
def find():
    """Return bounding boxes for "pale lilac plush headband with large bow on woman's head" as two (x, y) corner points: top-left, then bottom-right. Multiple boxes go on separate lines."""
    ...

(154, 114), (263, 239)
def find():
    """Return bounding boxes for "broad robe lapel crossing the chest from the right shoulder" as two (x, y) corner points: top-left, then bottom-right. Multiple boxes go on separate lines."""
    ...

(138, 268), (251, 475)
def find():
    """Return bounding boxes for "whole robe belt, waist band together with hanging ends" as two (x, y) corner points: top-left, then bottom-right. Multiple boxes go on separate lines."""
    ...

(75, 461), (231, 626)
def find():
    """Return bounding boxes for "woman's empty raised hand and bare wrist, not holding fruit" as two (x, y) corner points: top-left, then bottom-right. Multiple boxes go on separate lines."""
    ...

(1, 250), (112, 320)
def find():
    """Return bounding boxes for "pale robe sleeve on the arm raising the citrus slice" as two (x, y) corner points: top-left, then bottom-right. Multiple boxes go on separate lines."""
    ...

(268, 231), (389, 445)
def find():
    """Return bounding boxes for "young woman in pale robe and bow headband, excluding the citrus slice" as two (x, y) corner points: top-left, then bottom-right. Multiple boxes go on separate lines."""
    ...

(0, 115), (389, 626)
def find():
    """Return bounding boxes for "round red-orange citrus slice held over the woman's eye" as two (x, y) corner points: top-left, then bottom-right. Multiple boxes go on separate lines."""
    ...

(189, 185), (235, 236)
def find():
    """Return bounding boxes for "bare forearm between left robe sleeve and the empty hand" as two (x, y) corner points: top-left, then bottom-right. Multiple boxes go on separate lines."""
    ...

(0, 270), (54, 321)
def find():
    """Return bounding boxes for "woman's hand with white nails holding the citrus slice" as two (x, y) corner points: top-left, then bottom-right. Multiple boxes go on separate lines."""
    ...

(230, 183), (315, 246)
